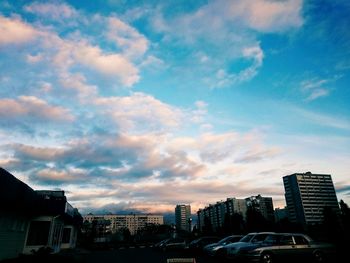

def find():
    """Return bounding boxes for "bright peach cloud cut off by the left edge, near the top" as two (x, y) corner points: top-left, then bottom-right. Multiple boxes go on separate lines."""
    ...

(0, 16), (39, 45)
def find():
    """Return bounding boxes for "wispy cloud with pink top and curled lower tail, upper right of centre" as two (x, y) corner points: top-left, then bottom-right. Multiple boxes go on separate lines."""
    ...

(152, 0), (303, 88)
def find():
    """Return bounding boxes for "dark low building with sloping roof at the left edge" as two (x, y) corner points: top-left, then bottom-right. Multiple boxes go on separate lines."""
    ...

(0, 168), (82, 260)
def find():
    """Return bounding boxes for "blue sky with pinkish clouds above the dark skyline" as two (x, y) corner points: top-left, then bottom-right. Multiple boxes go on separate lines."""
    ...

(0, 0), (350, 213)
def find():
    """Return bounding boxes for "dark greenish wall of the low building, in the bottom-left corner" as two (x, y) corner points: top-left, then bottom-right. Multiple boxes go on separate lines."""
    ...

(0, 215), (29, 260)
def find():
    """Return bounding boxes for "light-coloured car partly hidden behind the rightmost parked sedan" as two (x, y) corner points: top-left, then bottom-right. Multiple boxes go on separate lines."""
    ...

(217, 232), (276, 259)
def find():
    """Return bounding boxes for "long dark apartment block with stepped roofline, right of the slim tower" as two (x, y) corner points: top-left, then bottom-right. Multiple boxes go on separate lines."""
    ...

(197, 198), (247, 231)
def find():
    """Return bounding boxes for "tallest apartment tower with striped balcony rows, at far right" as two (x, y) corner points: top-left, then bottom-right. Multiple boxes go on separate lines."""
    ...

(283, 172), (339, 225)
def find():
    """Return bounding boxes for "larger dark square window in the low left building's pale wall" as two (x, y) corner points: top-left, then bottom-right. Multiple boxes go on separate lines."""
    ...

(27, 221), (50, 246)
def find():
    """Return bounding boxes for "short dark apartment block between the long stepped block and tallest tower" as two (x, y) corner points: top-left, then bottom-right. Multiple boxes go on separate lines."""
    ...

(245, 195), (275, 222)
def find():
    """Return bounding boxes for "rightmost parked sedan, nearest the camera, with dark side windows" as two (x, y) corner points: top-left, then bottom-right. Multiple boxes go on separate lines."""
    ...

(241, 233), (336, 263)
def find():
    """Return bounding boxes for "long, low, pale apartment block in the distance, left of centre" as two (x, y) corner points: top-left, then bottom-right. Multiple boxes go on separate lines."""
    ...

(83, 214), (164, 235)
